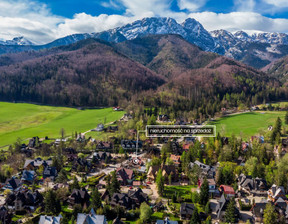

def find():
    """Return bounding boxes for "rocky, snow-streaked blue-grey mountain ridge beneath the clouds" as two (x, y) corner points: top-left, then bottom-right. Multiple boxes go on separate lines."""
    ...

(0, 17), (288, 69)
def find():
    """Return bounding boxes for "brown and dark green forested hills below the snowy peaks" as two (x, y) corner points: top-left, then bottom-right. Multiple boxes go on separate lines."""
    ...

(0, 34), (281, 108)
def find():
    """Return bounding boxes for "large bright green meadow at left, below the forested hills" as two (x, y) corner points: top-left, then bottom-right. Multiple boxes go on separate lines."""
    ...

(0, 102), (125, 146)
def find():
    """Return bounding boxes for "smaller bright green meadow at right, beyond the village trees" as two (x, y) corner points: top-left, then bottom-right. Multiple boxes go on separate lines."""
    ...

(209, 111), (286, 139)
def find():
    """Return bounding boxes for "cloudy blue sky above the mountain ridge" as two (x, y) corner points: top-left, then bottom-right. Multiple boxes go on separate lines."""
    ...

(0, 0), (288, 44)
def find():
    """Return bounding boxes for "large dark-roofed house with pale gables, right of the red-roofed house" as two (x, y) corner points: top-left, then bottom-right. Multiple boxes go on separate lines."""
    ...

(237, 174), (268, 197)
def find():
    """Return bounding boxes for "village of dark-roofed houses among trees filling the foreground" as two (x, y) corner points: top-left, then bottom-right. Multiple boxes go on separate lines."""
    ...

(0, 107), (288, 224)
